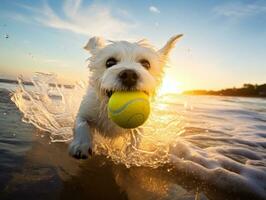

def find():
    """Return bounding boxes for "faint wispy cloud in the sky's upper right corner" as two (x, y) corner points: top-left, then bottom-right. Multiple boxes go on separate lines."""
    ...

(213, 2), (266, 18)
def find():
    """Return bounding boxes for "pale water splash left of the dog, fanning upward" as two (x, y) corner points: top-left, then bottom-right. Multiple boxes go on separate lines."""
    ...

(11, 73), (85, 142)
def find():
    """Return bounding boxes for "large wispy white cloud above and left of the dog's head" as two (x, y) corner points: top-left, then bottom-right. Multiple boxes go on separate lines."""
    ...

(14, 0), (134, 38)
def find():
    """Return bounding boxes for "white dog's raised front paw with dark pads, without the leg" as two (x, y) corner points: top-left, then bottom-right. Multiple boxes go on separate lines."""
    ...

(68, 141), (92, 159)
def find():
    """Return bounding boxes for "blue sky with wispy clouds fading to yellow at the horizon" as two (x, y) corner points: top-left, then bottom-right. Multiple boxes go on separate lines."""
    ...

(0, 0), (266, 91)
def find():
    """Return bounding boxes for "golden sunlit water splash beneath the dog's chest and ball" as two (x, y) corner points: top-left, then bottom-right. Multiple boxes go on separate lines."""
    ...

(94, 112), (183, 168)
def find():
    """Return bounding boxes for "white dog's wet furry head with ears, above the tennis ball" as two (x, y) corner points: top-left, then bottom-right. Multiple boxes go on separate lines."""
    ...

(85, 35), (182, 97)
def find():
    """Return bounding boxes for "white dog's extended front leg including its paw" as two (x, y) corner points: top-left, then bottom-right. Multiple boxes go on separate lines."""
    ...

(69, 116), (92, 159)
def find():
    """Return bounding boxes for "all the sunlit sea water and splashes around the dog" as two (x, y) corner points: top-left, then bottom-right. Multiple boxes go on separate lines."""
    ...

(0, 74), (266, 200)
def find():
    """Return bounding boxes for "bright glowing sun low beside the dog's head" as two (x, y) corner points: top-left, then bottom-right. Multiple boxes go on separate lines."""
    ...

(158, 76), (183, 95)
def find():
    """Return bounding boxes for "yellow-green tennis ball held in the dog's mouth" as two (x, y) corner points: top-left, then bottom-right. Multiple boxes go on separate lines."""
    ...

(108, 91), (150, 129)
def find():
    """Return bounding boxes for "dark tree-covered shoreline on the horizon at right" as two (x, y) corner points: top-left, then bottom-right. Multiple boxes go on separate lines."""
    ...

(182, 84), (266, 98)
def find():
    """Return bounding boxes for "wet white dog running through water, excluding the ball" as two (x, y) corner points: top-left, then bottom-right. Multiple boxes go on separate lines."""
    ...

(69, 35), (182, 159)
